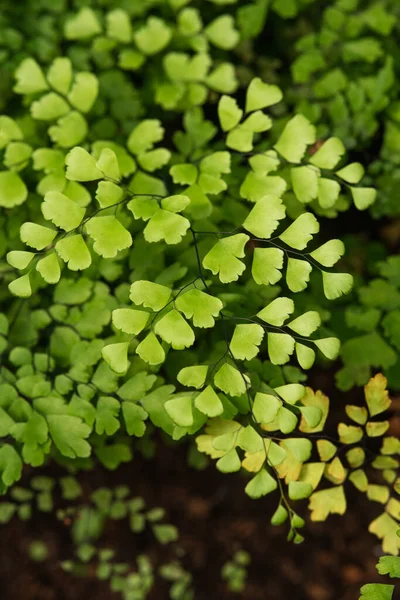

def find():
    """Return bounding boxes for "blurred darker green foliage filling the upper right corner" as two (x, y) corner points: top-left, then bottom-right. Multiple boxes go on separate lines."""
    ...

(291, 0), (400, 216)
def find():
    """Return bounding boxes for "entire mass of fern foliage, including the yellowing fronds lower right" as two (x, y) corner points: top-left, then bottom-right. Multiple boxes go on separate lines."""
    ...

(0, 0), (400, 600)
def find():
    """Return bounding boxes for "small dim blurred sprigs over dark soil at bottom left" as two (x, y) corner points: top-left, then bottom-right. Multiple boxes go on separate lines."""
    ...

(0, 476), (193, 600)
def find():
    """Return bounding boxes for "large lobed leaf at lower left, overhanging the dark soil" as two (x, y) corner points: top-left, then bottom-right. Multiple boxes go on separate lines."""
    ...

(46, 415), (91, 458)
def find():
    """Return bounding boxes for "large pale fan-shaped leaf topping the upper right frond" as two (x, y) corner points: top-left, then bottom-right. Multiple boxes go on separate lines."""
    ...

(274, 115), (315, 163)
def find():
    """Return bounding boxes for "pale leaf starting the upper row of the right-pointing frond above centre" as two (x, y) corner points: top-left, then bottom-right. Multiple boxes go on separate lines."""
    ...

(242, 196), (286, 239)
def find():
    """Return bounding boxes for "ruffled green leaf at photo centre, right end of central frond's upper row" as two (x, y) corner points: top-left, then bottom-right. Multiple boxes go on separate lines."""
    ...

(175, 289), (223, 327)
